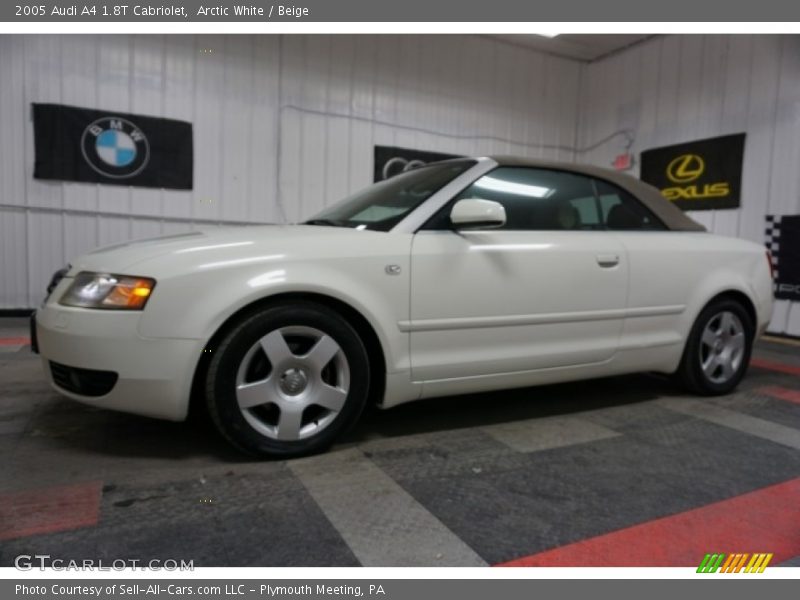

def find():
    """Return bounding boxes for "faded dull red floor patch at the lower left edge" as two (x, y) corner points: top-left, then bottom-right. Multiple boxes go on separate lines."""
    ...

(0, 481), (102, 540)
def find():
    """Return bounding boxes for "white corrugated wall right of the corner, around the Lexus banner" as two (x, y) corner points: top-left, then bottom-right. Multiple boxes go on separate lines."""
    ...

(578, 35), (800, 336)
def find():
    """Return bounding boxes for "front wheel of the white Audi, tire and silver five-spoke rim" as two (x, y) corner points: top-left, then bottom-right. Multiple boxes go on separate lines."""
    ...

(206, 303), (369, 457)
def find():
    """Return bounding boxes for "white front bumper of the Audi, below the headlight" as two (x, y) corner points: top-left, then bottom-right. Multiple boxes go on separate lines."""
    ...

(32, 294), (202, 421)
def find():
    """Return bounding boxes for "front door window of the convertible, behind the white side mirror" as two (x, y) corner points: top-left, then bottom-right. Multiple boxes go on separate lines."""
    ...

(426, 167), (602, 231)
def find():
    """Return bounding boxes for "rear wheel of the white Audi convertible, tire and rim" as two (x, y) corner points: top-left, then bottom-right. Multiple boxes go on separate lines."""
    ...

(677, 299), (754, 396)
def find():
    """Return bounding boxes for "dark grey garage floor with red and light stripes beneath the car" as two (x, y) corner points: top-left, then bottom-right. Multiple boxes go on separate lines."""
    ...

(0, 319), (800, 566)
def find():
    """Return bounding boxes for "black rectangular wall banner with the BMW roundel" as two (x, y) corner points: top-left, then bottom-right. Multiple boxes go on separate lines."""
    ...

(33, 104), (193, 190)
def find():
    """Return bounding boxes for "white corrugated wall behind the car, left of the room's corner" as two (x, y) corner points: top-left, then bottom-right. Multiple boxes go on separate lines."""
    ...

(0, 35), (581, 309)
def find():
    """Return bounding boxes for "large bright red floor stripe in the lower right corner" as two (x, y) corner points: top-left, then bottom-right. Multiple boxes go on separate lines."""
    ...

(498, 478), (800, 567)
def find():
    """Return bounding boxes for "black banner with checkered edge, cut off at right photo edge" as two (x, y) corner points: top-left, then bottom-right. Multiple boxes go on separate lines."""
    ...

(764, 215), (800, 302)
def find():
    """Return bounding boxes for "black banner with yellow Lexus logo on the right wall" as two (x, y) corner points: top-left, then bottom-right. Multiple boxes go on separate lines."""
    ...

(641, 133), (745, 210)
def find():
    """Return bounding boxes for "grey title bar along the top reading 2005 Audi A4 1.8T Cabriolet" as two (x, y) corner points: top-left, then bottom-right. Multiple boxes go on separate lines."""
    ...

(0, 0), (800, 22)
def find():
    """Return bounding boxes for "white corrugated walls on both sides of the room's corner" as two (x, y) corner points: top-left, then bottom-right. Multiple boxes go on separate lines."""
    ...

(0, 35), (800, 335)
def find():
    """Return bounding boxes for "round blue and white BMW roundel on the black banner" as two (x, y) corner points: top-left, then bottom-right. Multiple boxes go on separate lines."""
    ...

(81, 117), (150, 178)
